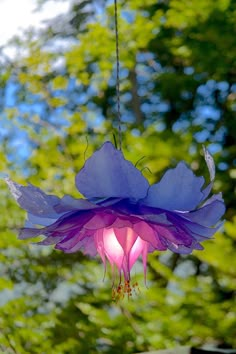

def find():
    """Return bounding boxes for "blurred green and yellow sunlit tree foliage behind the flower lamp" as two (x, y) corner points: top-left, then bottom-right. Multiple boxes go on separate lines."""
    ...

(0, 0), (236, 354)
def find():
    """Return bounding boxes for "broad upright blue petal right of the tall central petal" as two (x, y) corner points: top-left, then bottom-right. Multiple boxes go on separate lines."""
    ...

(143, 162), (204, 211)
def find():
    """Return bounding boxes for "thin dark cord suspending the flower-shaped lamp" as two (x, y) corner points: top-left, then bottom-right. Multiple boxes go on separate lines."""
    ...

(114, 0), (122, 150)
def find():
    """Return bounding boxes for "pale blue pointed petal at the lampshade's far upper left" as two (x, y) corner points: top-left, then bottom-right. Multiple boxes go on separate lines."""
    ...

(6, 178), (60, 218)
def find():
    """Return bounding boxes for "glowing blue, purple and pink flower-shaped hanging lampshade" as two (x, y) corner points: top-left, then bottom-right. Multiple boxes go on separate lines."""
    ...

(7, 142), (225, 297)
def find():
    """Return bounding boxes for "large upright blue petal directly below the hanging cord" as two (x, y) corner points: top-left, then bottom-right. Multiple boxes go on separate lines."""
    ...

(76, 142), (149, 199)
